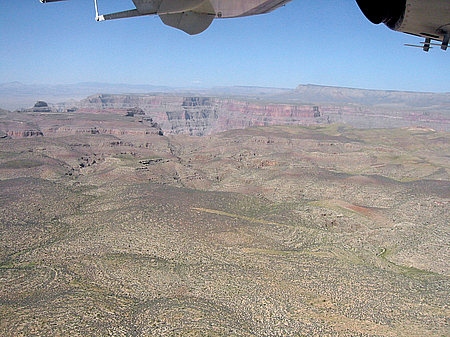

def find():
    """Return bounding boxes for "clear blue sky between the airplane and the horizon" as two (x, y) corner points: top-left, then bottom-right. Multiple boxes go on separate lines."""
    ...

(0, 0), (450, 92)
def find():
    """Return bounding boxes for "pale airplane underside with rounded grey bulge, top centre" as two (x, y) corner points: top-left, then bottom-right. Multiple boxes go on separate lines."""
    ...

(133, 0), (291, 35)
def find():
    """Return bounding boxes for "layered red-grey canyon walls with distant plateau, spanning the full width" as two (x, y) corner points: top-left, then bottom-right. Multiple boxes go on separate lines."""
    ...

(0, 85), (450, 137)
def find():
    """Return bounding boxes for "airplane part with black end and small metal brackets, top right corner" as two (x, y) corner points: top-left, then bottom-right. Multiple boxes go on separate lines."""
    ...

(356, 0), (450, 51)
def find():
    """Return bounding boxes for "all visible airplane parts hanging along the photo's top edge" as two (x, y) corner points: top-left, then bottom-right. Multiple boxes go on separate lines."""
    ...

(40, 0), (450, 51)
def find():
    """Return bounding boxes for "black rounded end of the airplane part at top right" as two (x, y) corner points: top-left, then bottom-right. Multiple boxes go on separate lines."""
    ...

(356, 0), (406, 30)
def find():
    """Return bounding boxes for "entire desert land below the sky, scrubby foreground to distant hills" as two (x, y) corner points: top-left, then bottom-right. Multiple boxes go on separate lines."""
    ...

(0, 83), (450, 336)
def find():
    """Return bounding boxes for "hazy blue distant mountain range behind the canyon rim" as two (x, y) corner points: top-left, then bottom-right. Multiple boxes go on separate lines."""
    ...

(0, 82), (450, 113)
